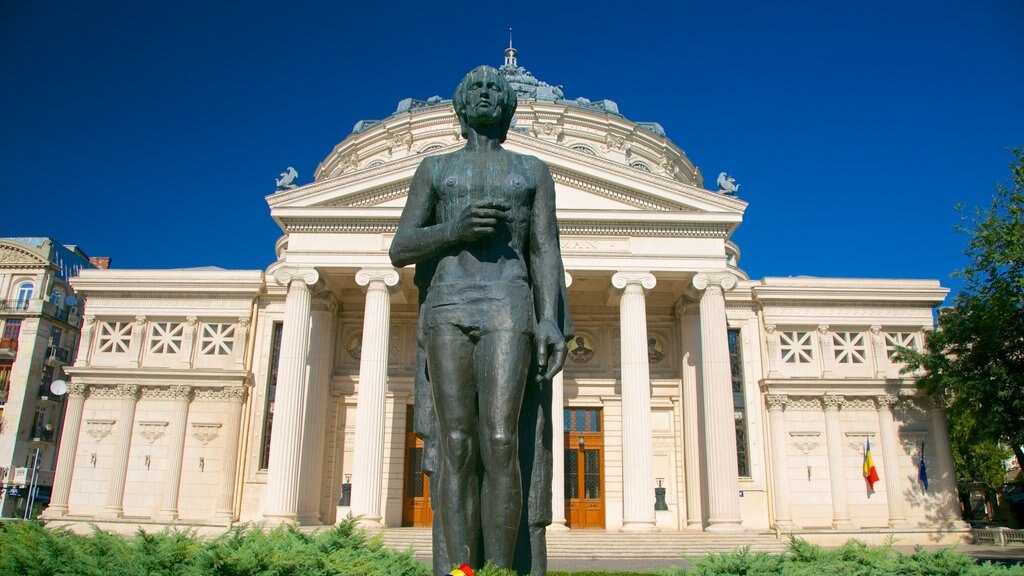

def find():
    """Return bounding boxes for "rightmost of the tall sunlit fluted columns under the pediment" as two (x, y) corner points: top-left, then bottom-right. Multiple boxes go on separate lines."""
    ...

(693, 274), (743, 532)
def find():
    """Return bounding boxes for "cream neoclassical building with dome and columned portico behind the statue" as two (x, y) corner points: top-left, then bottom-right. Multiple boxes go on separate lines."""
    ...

(46, 48), (958, 539)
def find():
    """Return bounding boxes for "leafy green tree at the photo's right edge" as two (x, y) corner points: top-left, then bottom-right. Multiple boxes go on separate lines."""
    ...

(900, 148), (1024, 475)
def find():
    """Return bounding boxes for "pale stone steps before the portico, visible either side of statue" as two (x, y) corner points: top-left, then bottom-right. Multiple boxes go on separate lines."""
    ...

(381, 528), (786, 559)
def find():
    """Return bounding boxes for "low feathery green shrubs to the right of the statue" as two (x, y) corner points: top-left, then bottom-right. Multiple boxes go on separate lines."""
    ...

(660, 538), (1024, 576)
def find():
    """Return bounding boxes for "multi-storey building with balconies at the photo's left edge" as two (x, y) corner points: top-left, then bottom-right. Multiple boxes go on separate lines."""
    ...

(0, 238), (94, 518)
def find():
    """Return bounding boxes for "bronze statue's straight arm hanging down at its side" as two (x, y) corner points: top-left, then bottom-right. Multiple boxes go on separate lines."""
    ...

(529, 158), (567, 381)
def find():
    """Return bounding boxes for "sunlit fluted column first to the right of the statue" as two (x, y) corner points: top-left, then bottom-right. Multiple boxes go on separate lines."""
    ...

(611, 272), (657, 531)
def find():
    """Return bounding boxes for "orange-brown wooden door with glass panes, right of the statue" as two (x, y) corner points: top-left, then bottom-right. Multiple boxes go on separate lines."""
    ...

(563, 408), (604, 529)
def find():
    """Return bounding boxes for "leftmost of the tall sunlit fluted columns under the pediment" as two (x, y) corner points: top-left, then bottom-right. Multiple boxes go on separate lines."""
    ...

(263, 269), (319, 523)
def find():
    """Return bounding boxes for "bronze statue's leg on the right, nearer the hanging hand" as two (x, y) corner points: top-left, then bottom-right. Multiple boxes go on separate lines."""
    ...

(474, 330), (532, 568)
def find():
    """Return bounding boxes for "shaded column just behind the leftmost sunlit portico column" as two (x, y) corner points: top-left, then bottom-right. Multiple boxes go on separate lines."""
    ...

(299, 293), (338, 524)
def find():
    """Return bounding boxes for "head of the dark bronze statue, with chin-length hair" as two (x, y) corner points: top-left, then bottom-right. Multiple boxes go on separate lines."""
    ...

(452, 66), (518, 141)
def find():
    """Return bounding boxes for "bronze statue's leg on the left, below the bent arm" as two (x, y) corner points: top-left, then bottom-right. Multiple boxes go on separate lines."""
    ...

(427, 324), (483, 567)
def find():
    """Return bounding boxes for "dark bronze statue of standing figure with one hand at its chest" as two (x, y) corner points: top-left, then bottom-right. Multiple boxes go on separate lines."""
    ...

(390, 67), (572, 576)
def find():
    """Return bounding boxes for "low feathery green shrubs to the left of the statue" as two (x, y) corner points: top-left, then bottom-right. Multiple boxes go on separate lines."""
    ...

(0, 522), (430, 576)
